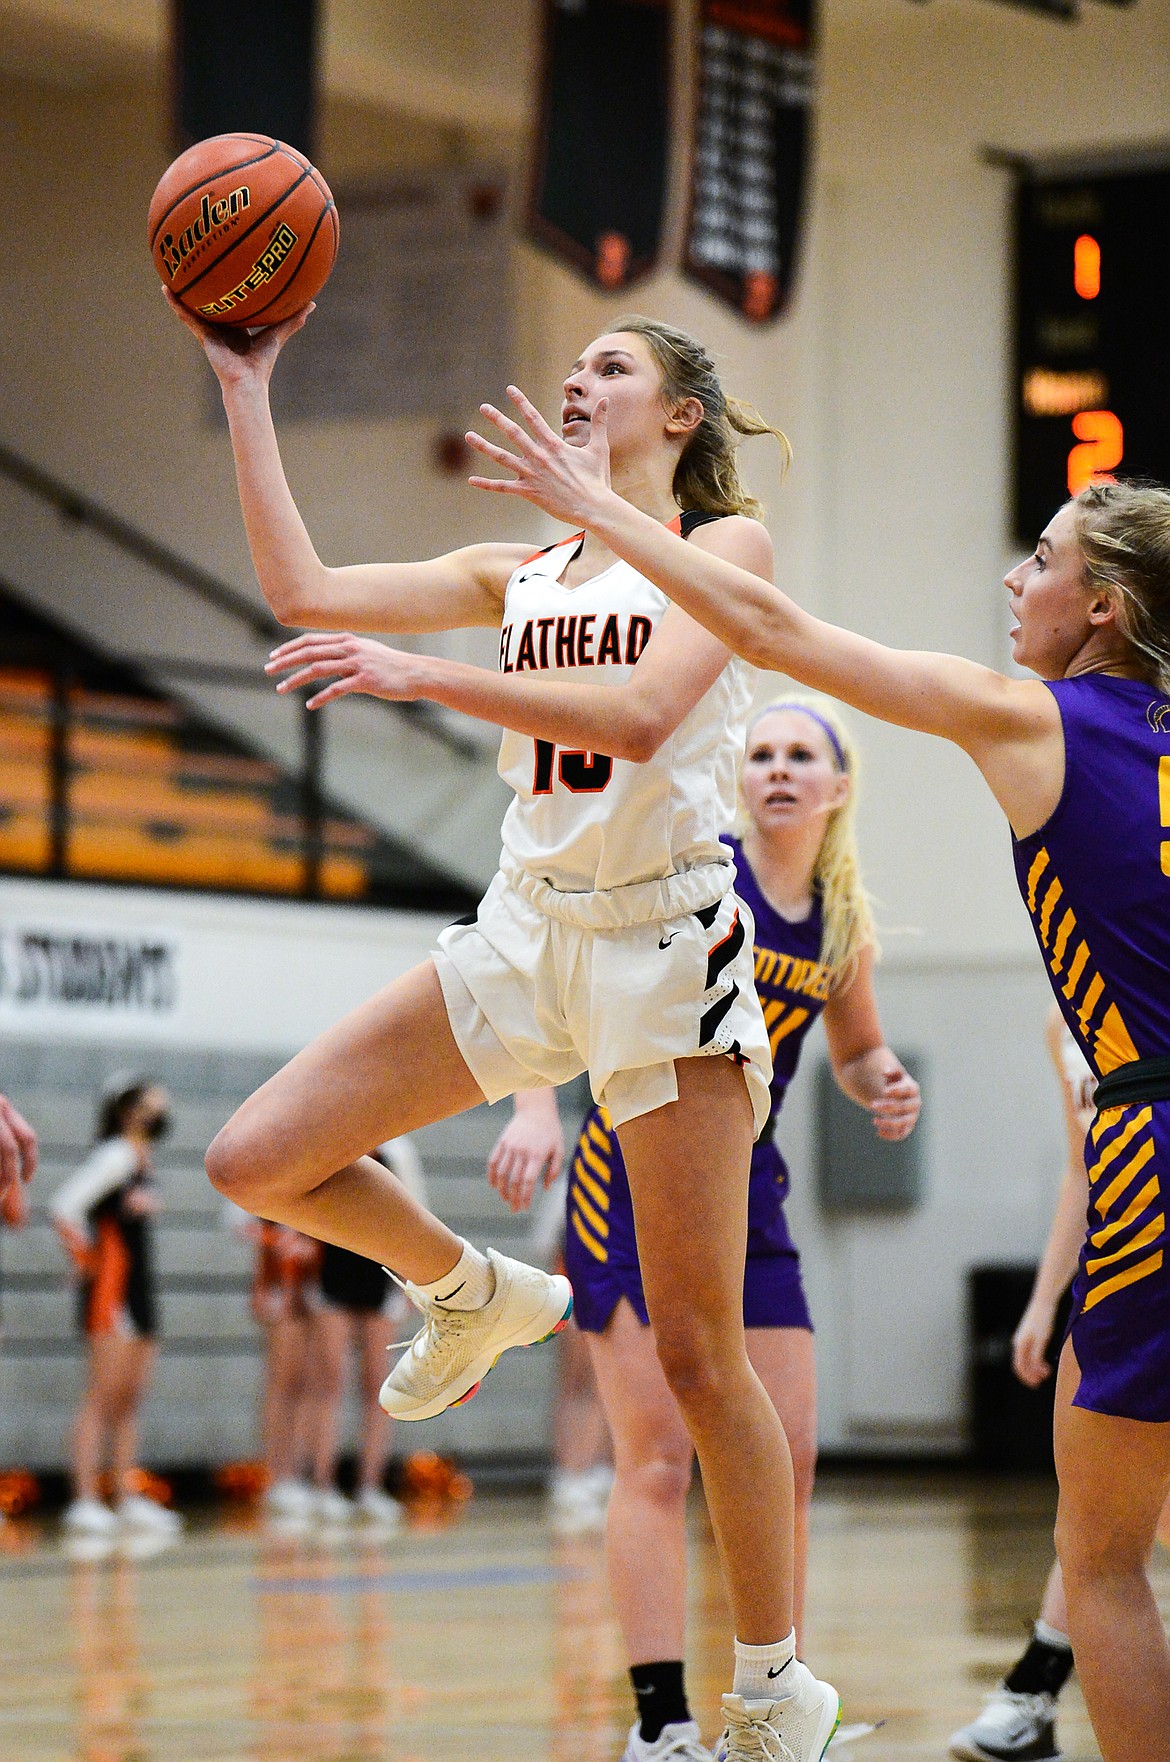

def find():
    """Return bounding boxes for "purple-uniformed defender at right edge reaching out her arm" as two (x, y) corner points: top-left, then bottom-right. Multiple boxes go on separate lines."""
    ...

(482, 408), (1170, 1762)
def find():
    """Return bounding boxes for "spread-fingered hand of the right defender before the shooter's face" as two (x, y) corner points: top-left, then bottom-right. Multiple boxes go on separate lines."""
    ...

(467, 386), (610, 527)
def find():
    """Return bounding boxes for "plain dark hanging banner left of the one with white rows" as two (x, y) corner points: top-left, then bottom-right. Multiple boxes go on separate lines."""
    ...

(527, 0), (670, 287)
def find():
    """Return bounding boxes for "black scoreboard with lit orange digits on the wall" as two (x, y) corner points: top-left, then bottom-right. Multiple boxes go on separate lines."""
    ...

(1013, 164), (1170, 544)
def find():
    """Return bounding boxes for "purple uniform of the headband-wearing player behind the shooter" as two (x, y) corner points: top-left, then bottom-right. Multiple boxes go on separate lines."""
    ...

(566, 835), (830, 1334)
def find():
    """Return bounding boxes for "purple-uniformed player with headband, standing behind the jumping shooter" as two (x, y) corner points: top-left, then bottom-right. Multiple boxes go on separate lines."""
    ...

(497, 700), (918, 1762)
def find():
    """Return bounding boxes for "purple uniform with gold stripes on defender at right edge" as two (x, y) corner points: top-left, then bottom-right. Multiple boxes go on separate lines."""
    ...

(1015, 675), (1170, 1422)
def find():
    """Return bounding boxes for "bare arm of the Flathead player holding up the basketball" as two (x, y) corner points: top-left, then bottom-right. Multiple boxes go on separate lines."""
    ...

(158, 292), (530, 633)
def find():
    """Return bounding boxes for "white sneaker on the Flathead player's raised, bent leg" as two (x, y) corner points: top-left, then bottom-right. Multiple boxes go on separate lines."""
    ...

(377, 1247), (573, 1420)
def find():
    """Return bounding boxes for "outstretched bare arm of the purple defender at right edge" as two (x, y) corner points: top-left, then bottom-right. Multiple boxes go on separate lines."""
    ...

(467, 386), (1063, 832)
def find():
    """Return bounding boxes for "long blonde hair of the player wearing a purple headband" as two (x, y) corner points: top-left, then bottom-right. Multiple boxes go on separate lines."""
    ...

(740, 696), (881, 990)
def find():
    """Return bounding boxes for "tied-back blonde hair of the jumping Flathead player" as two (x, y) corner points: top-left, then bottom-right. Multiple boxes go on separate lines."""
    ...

(613, 314), (793, 520)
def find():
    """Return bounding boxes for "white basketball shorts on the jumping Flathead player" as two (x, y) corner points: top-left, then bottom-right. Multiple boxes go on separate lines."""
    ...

(433, 863), (772, 1131)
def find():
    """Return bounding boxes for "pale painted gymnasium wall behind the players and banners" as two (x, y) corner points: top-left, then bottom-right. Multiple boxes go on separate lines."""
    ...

(0, 0), (1170, 1447)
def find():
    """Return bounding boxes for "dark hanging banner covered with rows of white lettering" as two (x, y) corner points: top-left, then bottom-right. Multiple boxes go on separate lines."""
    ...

(684, 0), (814, 322)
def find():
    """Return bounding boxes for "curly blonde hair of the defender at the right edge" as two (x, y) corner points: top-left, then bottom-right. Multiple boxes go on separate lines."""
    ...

(1071, 483), (1170, 692)
